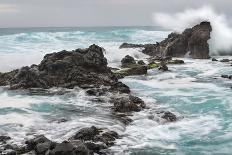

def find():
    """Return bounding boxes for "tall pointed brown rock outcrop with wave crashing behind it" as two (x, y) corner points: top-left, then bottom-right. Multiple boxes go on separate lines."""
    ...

(120, 22), (212, 59)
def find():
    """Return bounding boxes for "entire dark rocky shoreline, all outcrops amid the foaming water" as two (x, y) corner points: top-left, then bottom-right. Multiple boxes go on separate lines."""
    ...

(0, 22), (231, 155)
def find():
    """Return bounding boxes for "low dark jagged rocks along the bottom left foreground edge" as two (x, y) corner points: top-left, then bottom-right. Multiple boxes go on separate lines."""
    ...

(2, 126), (119, 155)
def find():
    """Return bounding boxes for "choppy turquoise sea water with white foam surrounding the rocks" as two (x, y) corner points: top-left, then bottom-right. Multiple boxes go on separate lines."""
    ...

(0, 27), (232, 155)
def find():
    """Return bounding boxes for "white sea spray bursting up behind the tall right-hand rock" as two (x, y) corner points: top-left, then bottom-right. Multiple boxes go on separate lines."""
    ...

(154, 6), (232, 55)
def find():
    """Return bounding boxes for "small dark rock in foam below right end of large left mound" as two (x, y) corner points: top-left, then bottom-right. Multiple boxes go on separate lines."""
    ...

(111, 95), (146, 112)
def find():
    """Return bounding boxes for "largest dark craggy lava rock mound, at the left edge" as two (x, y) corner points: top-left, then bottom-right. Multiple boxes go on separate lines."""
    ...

(0, 45), (117, 89)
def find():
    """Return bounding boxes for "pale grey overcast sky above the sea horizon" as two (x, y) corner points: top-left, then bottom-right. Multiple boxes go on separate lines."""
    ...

(0, 0), (232, 27)
